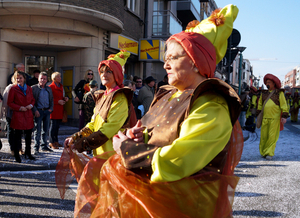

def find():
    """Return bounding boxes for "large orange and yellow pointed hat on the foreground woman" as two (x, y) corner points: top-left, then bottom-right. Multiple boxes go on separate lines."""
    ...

(167, 5), (238, 78)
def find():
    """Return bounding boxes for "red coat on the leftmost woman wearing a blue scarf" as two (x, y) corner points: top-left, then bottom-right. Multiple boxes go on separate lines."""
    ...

(7, 85), (35, 130)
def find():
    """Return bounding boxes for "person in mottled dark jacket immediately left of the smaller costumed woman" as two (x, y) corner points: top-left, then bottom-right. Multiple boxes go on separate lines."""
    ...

(82, 80), (98, 125)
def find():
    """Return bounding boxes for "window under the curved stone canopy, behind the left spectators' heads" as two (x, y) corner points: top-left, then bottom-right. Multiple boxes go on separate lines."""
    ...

(25, 55), (55, 81)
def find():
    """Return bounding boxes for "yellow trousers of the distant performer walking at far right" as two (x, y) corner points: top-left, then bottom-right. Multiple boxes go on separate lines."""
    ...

(259, 118), (280, 156)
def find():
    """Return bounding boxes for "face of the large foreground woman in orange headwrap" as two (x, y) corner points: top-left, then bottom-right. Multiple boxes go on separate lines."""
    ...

(164, 42), (198, 91)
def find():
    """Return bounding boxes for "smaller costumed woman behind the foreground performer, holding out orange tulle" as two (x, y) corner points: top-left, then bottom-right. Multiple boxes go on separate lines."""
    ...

(55, 50), (134, 198)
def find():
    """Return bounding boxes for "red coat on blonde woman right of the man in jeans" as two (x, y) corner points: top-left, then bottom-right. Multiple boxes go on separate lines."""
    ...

(49, 82), (64, 120)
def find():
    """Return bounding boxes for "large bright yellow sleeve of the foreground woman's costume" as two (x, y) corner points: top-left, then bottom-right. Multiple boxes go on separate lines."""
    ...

(151, 94), (232, 182)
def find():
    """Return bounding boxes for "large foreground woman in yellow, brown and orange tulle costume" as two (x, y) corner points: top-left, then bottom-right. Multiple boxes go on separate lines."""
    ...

(75, 5), (243, 218)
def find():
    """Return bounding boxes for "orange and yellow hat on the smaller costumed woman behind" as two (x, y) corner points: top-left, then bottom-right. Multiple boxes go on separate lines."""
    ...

(98, 50), (130, 88)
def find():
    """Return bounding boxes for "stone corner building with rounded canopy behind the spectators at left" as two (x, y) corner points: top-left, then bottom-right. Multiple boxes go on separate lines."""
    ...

(0, 0), (145, 118)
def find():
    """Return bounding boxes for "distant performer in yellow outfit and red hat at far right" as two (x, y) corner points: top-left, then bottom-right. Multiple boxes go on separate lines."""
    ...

(256, 73), (289, 160)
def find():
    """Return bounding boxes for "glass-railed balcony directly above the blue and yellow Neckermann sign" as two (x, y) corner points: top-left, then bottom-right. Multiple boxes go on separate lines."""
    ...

(152, 10), (182, 39)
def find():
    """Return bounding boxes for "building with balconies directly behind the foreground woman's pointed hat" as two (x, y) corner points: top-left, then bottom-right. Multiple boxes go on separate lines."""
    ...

(140, 0), (216, 81)
